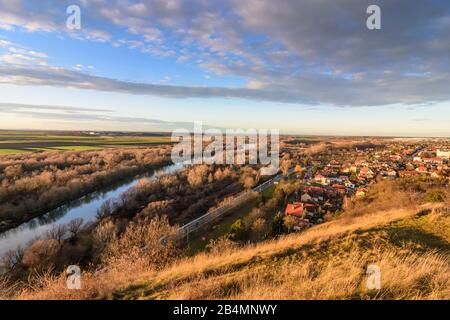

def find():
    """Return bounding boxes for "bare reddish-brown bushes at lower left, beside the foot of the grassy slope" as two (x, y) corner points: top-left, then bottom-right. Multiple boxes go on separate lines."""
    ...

(12, 216), (178, 299)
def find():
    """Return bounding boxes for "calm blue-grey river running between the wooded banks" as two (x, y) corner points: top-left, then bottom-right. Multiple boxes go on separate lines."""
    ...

(0, 164), (183, 257)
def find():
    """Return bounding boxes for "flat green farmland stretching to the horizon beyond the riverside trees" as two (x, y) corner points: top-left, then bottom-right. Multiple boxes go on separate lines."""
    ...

(0, 131), (171, 156)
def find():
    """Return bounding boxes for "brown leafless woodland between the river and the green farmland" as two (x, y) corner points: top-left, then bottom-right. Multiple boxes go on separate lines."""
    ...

(0, 146), (170, 231)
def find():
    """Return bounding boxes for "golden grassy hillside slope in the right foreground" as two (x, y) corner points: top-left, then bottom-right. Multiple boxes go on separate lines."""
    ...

(107, 205), (450, 299)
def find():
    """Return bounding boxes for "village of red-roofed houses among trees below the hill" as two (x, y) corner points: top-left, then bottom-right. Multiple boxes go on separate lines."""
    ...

(283, 143), (450, 231)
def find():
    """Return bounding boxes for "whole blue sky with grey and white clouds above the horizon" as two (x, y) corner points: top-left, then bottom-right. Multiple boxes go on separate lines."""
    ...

(0, 0), (450, 137)
